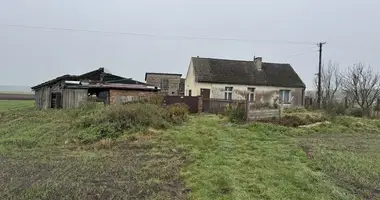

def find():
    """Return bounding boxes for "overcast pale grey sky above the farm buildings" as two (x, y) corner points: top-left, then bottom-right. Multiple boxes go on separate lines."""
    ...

(0, 0), (380, 87)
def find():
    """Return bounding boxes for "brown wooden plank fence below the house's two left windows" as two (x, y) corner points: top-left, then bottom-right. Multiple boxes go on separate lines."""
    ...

(202, 99), (245, 114)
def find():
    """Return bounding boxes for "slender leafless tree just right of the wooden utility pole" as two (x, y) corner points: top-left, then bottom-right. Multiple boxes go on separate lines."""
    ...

(314, 60), (342, 107)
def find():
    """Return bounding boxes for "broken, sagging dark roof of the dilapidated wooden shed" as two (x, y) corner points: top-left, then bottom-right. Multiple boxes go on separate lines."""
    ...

(32, 68), (147, 90)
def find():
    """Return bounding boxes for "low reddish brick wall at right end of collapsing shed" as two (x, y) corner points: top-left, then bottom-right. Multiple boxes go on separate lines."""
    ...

(109, 90), (157, 105)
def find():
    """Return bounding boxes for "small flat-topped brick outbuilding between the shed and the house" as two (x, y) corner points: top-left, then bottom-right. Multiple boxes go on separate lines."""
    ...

(146, 74), (181, 95)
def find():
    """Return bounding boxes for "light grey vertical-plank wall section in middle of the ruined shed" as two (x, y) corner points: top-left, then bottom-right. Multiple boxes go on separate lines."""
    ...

(62, 89), (88, 108)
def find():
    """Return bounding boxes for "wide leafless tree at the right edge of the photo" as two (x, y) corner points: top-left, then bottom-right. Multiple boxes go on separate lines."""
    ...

(342, 63), (380, 115)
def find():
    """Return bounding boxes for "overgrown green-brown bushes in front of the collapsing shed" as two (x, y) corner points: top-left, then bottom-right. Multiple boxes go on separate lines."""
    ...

(75, 103), (188, 142)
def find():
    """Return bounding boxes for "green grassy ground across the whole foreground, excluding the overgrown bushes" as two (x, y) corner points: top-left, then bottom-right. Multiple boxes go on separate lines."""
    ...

(0, 103), (380, 200)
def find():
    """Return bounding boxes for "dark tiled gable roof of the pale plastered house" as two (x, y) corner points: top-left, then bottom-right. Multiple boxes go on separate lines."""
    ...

(191, 57), (306, 88)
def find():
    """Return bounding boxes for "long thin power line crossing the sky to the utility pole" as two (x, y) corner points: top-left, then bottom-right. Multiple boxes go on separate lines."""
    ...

(0, 24), (315, 45)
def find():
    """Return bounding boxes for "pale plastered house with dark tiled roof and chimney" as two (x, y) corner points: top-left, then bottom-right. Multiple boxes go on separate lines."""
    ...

(185, 57), (306, 106)
